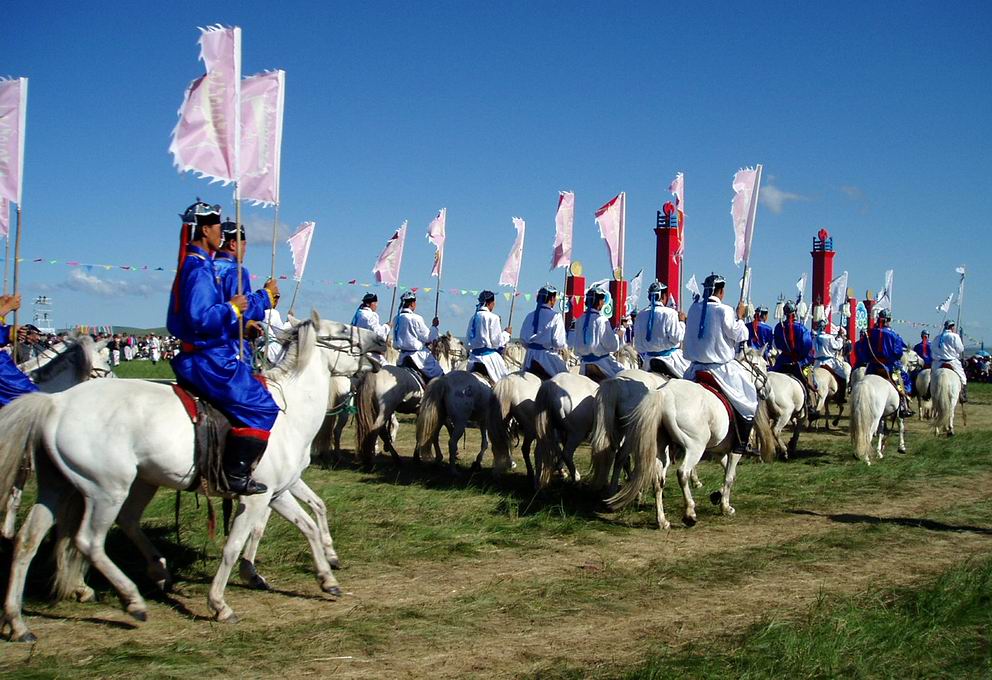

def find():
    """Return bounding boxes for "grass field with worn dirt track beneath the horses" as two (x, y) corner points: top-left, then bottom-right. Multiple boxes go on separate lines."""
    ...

(0, 386), (992, 678)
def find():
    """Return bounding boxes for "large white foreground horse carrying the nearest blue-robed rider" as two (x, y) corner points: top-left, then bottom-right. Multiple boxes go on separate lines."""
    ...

(0, 313), (385, 641)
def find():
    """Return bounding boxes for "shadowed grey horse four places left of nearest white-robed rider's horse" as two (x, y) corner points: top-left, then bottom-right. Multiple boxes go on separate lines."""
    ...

(414, 371), (511, 473)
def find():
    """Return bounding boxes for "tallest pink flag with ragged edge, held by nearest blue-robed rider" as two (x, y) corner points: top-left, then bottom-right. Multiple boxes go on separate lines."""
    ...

(169, 26), (241, 184)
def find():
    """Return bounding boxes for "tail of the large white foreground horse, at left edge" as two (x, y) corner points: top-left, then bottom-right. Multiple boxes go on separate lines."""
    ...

(0, 392), (55, 507)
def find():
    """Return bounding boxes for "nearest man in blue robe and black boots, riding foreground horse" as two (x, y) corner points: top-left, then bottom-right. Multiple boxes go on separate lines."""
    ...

(167, 202), (279, 495)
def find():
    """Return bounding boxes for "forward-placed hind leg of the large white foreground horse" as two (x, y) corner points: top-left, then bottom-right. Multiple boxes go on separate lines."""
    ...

(76, 491), (148, 621)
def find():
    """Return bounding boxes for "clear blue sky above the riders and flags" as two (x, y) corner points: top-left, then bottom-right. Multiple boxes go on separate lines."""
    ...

(0, 2), (992, 341)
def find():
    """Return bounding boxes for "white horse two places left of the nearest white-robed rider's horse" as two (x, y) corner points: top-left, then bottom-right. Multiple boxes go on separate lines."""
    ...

(534, 373), (598, 488)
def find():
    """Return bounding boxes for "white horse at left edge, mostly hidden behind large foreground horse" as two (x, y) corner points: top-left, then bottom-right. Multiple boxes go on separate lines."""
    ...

(0, 335), (115, 540)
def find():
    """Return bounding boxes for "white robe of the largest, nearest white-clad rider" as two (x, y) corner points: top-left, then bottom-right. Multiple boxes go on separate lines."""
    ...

(683, 296), (758, 420)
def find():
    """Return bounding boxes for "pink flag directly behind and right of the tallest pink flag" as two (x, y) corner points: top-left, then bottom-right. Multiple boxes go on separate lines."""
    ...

(238, 71), (286, 205)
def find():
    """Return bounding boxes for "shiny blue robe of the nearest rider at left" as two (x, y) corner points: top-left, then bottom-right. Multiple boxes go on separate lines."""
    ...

(166, 246), (279, 431)
